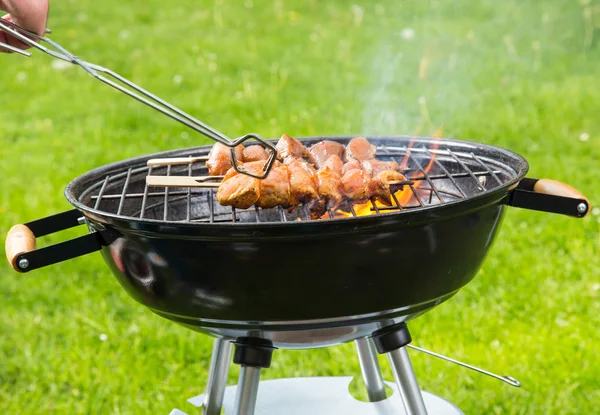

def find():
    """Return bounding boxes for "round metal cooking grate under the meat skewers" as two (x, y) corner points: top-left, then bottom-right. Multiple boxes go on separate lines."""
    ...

(79, 140), (517, 223)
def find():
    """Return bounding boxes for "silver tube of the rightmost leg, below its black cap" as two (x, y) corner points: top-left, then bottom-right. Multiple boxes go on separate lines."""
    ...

(387, 347), (427, 415)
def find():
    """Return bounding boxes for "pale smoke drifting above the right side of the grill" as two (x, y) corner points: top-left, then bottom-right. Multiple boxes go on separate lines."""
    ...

(362, 22), (481, 136)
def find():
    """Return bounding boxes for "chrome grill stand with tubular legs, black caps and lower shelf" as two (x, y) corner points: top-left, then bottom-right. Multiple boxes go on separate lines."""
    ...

(170, 323), (520, 415)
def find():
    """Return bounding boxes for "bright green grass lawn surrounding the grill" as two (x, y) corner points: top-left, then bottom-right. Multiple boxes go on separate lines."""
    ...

(0, 0), (600, 415)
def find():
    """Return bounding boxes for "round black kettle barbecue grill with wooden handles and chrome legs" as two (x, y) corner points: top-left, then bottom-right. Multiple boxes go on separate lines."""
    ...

(0, 20), (590, 414)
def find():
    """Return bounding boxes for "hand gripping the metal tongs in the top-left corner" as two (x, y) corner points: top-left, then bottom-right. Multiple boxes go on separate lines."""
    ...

(0, 0), (48, 52)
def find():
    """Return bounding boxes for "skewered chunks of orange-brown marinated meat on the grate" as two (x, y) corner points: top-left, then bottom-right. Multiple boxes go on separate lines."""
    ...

(150, 134), (406, 217)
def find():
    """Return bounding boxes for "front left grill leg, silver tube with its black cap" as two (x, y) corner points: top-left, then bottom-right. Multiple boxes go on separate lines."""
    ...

(233, 338), (274, 415)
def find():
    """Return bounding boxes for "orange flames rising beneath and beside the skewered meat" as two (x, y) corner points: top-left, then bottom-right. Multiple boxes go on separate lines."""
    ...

(321, 126), (444, 219)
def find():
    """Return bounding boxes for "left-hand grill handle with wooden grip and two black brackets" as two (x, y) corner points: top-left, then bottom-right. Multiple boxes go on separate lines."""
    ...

(4, 209), (108, 273)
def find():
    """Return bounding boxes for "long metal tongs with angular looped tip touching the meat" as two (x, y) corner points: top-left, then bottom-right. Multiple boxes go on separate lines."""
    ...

(0, 19), (277, 179)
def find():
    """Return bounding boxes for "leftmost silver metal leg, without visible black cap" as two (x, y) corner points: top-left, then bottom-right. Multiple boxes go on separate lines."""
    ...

(202, 338), (231, 415)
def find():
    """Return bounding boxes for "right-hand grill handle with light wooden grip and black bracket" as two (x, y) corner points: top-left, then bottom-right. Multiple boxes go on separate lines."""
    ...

(503, 178), (591, 218)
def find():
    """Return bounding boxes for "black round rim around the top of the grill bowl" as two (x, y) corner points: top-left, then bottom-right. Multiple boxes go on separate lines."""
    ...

(64, 135), (529, 233)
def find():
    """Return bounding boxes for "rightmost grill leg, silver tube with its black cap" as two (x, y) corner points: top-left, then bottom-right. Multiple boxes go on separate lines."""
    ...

(372, 323), (427, 415)
